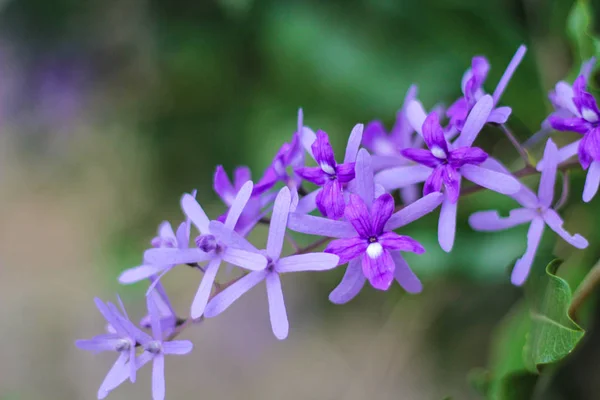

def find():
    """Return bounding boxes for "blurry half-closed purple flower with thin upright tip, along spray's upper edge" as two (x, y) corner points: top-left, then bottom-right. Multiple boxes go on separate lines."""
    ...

(254, 109), (305, 195)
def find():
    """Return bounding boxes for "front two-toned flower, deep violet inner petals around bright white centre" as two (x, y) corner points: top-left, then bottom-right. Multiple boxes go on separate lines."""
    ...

(288, 149), (443, 304)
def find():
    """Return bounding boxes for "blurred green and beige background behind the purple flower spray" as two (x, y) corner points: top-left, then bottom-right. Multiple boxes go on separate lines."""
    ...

(0, 0), (600, 400)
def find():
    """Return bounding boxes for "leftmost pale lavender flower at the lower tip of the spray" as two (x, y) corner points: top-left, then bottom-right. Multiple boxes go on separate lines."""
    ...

(75, 298), (143, 399)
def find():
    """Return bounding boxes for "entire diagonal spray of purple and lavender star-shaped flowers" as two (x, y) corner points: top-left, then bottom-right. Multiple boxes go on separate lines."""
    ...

(77, 46), (600, 400)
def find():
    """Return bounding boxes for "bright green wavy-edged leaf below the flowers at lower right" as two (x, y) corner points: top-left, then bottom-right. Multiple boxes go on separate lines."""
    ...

(471, 260), (584, 400)
